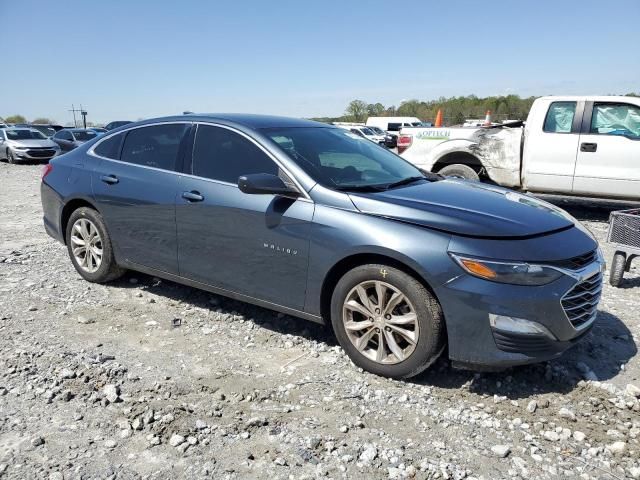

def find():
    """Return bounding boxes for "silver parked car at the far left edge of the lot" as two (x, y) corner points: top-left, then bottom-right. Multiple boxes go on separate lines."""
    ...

(0, 127), (60, 163)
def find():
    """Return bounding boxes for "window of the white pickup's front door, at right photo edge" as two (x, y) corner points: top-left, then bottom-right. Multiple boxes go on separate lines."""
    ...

(590, 103), (640, 138)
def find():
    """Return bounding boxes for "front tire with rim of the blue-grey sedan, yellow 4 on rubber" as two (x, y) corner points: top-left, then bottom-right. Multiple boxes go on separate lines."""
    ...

(331, 264), (445, 379)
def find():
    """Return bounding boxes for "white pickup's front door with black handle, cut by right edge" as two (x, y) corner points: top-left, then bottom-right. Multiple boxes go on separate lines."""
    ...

(573, 102), (640, 198)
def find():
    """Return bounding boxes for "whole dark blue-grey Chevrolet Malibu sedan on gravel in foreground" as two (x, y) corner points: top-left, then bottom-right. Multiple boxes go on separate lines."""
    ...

(41, 114), (604, 378)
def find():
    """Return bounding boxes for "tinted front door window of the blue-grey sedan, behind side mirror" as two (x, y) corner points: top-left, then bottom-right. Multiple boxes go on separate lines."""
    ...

(191, 125), (279, 184)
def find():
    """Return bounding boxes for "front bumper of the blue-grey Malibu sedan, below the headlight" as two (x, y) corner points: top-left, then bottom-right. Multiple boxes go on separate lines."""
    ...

(436, 259), (604, 368)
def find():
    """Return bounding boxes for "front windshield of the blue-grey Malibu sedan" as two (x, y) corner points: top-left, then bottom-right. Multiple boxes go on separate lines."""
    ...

(263, 127), (423, 190)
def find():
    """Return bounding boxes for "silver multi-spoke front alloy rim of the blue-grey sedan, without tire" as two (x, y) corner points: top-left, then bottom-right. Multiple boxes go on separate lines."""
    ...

(342, 280), (420, 364)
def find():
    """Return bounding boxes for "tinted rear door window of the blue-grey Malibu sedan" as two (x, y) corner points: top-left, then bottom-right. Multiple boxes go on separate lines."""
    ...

(120, 123), (190, 170)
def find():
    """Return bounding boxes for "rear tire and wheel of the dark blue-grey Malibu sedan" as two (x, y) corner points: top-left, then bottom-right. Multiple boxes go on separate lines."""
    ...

(65, 207), (125, 283)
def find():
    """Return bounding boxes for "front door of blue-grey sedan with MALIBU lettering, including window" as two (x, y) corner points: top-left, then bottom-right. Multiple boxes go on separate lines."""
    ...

(176, 124), (314, 310)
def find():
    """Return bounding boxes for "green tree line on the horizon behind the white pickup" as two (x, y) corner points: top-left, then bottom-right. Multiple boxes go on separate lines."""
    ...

(313, 93), (640, 125)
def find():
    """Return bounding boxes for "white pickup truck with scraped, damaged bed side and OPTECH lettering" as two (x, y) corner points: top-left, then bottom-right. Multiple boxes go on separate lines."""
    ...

(398, 96), (640, 200)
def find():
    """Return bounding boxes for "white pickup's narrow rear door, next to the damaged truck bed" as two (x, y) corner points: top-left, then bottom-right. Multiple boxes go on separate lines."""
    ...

(522, 100), (584, 193)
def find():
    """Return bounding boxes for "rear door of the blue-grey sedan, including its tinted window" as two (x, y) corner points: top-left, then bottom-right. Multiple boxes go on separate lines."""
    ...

(92, 122), (191, 275)
